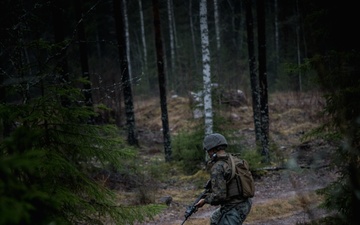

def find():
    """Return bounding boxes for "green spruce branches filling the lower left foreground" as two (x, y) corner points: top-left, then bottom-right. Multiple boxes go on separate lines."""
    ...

(0, 85), (163, 225)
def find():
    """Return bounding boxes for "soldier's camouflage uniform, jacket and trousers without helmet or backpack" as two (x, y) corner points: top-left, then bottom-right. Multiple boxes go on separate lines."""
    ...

(205, 156), (252, 225)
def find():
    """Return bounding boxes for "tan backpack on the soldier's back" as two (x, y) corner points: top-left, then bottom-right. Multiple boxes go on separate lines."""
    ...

(228, 154), (255, 198)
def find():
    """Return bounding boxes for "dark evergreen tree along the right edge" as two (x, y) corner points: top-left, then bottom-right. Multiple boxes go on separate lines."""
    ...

(302, 1), (360, 225)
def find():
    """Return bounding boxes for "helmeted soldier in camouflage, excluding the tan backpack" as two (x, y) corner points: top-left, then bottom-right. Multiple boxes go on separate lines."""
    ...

(195, 133), (252, 225)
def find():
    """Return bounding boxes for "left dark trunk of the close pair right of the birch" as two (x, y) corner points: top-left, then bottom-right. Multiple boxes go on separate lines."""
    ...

(244, 0), (261, 146)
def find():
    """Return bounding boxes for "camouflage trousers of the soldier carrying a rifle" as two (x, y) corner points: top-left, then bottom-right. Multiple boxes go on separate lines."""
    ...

(210, 198), (252, 225)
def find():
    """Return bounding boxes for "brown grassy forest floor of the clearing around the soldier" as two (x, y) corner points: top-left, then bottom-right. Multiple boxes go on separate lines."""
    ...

(120, 93), (336, 225)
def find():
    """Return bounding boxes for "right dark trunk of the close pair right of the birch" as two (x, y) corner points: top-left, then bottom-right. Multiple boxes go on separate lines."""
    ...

(256, 0), (270, 162)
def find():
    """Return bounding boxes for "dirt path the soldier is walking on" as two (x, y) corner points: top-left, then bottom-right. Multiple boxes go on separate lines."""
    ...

(138, 163), (335, 225)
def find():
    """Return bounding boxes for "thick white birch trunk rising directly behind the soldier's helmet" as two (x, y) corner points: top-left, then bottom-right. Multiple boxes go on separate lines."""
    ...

(200, 0), (213, 135)
